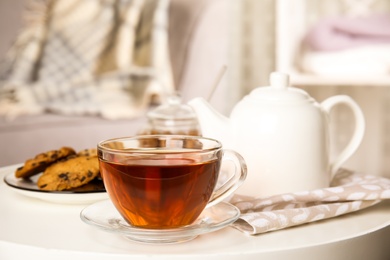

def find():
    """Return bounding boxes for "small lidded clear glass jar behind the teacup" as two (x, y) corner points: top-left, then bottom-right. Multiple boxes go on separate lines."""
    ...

(139, 94), (201, 136)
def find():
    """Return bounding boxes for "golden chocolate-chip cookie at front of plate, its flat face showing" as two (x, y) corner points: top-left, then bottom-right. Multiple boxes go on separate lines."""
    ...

(37, 156), (100, 191)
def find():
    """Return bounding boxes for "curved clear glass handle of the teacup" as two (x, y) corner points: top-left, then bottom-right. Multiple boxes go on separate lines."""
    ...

(206, 149), (247, 208)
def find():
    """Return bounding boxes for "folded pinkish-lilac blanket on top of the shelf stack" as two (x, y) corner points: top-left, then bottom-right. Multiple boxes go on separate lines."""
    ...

(304, 14), (390, 51)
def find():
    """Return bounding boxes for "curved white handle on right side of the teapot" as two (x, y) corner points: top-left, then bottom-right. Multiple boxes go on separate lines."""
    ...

(321, 95), (365, 179)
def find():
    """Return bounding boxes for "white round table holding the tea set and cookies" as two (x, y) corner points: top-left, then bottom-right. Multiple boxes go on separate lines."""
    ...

(0, 167), (390, 260)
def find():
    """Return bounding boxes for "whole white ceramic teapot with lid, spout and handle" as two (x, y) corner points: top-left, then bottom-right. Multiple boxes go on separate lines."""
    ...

(188, 72), (365, 196)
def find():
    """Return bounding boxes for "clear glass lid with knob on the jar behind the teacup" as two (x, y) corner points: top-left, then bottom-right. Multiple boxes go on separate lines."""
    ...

(147, 94), (196, 120)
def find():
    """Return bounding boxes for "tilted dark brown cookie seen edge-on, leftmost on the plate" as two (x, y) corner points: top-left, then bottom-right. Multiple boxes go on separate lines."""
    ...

(15, 146), (76, 179)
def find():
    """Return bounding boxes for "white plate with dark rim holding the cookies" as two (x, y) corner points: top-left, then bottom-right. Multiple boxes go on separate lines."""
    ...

(4, 165), (108, 204)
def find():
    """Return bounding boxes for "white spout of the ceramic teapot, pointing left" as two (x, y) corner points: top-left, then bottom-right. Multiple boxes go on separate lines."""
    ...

(188, 97), (230, 144)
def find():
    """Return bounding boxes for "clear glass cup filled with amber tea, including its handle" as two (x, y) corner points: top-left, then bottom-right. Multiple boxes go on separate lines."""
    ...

(98, 135), (247, 229)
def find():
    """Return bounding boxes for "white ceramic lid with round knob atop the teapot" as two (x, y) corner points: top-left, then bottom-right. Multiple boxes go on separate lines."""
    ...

(250, 72), (311, 102)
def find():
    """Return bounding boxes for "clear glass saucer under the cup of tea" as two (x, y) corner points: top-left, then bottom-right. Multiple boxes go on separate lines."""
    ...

(80, 200), (240, 244)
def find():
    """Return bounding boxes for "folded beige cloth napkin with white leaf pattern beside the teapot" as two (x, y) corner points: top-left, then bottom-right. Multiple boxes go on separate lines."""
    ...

(230, 169), (390, 235)
